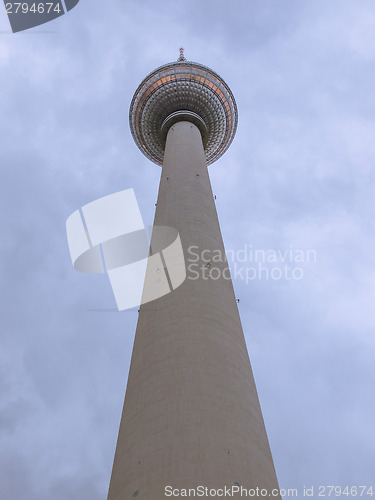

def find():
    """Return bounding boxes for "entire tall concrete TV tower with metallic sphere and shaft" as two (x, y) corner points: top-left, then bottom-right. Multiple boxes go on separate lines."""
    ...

(108, 49), (280, 500)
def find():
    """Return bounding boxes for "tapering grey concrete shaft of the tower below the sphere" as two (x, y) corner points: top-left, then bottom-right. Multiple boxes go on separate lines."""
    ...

(108, 121), (278, 500)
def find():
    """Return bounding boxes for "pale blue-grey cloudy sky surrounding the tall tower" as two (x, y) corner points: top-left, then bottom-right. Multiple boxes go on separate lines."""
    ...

(0, 0), (375, 500)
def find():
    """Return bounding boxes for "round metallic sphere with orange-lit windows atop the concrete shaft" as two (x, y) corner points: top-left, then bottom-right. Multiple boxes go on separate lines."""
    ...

(129, 57), (238, 165)
